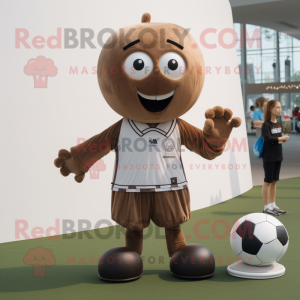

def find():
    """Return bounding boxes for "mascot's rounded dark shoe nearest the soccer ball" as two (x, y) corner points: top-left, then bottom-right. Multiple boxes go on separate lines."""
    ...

(170, 244), (215, 279)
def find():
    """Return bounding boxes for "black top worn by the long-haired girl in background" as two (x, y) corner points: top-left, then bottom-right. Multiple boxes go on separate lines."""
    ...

(261, 120), (283, 162)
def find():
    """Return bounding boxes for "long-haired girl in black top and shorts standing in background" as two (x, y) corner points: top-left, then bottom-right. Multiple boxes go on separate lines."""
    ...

(261, 100), (289, 216)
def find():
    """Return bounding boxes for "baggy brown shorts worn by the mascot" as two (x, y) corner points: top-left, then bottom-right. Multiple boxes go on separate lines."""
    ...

(111, 188), (191, 230)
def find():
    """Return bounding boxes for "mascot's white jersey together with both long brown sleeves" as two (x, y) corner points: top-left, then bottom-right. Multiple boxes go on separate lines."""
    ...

(71, 118), (223, 192)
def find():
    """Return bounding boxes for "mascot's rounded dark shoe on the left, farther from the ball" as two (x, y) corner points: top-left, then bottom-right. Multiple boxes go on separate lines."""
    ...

(98, 247), (143, 282)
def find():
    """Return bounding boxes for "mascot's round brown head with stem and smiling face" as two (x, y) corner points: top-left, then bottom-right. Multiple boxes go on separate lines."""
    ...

(97, 13), (205, 123)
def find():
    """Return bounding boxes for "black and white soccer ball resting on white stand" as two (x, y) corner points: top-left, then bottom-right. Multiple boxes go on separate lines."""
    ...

(230, 213), (289, 266)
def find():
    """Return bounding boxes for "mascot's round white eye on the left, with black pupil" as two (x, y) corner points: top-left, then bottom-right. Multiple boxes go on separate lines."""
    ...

(124, 52), (153, 79)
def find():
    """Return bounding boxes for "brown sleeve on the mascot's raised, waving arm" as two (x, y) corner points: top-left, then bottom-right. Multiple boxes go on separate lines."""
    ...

(177, 118), (226, 160)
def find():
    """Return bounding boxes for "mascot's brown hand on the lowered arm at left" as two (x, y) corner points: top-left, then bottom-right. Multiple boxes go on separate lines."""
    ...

(54, 149), (85, 183)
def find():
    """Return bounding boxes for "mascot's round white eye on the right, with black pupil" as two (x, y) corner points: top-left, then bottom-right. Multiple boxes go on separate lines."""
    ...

(159, 52), (185, 79)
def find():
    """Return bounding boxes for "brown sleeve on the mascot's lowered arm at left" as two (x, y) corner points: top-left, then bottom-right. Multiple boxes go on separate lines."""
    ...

(71, 119), (123, 173)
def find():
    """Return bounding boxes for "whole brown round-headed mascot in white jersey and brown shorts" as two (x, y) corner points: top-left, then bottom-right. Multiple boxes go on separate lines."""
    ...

(54, 13), (242, 281)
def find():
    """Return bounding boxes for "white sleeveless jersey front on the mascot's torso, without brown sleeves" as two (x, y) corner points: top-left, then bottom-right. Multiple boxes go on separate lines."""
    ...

(112, 118), (188, 192)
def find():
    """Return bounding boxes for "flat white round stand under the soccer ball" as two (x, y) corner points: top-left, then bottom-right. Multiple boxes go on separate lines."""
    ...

(227, 262), (285, 279)
